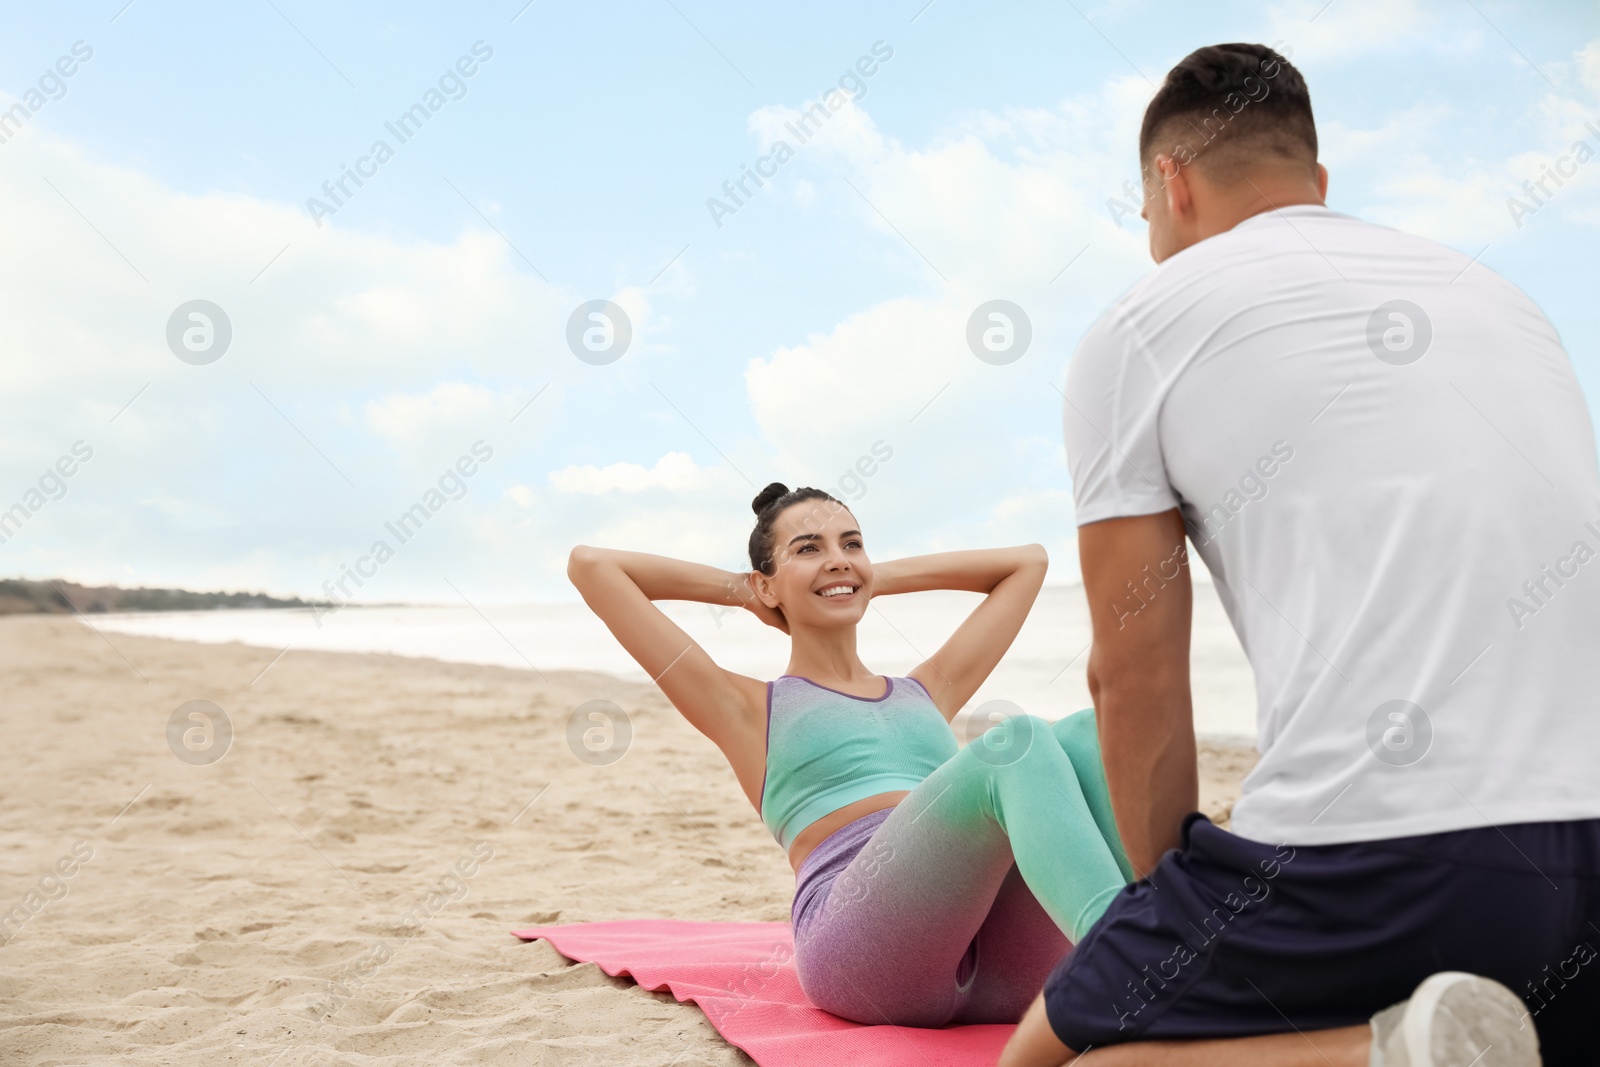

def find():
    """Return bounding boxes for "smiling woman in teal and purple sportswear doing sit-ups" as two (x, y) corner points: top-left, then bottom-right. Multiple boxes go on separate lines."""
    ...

(566, 483), (1133, 1027)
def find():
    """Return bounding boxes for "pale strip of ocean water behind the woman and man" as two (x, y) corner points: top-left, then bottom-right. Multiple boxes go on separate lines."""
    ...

(93, 582), (1256, 739)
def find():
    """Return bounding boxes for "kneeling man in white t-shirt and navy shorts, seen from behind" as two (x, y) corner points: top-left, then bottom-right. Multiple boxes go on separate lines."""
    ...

(1002, 45), (1600, 1067)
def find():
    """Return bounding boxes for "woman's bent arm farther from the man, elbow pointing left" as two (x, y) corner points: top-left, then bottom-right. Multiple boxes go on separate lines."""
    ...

(566, 545), (766, 751)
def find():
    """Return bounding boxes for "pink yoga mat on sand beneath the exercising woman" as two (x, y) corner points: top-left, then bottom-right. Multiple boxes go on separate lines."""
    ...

(512, 918), (1014, 1067)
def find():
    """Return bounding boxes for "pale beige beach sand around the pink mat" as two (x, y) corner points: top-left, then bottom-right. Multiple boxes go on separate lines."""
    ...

(0, 616), (1254, 1067)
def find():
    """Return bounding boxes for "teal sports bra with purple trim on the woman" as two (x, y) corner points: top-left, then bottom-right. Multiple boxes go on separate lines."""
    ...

(762, 675), (957, 853)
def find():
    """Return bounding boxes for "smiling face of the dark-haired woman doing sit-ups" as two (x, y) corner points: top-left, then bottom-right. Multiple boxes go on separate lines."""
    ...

(757, 501), (872, 632)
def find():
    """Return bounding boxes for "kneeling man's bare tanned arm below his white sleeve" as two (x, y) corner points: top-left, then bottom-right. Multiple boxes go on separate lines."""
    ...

(1078, 509), (1200, 877)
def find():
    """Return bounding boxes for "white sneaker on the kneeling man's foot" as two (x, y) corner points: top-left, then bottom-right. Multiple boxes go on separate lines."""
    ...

(1371, 971), (1542, 1067)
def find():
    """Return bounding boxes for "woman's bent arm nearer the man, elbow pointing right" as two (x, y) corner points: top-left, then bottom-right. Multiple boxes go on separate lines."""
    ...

(872, 544), (1050, 720)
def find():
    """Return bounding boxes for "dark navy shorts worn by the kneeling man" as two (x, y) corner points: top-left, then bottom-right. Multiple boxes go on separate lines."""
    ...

(1045, 813), (1600, 1067)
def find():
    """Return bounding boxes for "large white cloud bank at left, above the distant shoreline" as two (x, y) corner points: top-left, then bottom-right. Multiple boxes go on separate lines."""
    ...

(0, 113), (585, 418)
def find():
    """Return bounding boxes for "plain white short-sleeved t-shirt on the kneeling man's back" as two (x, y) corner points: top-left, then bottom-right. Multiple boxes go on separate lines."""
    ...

(1064, 205), (1600, 845)
